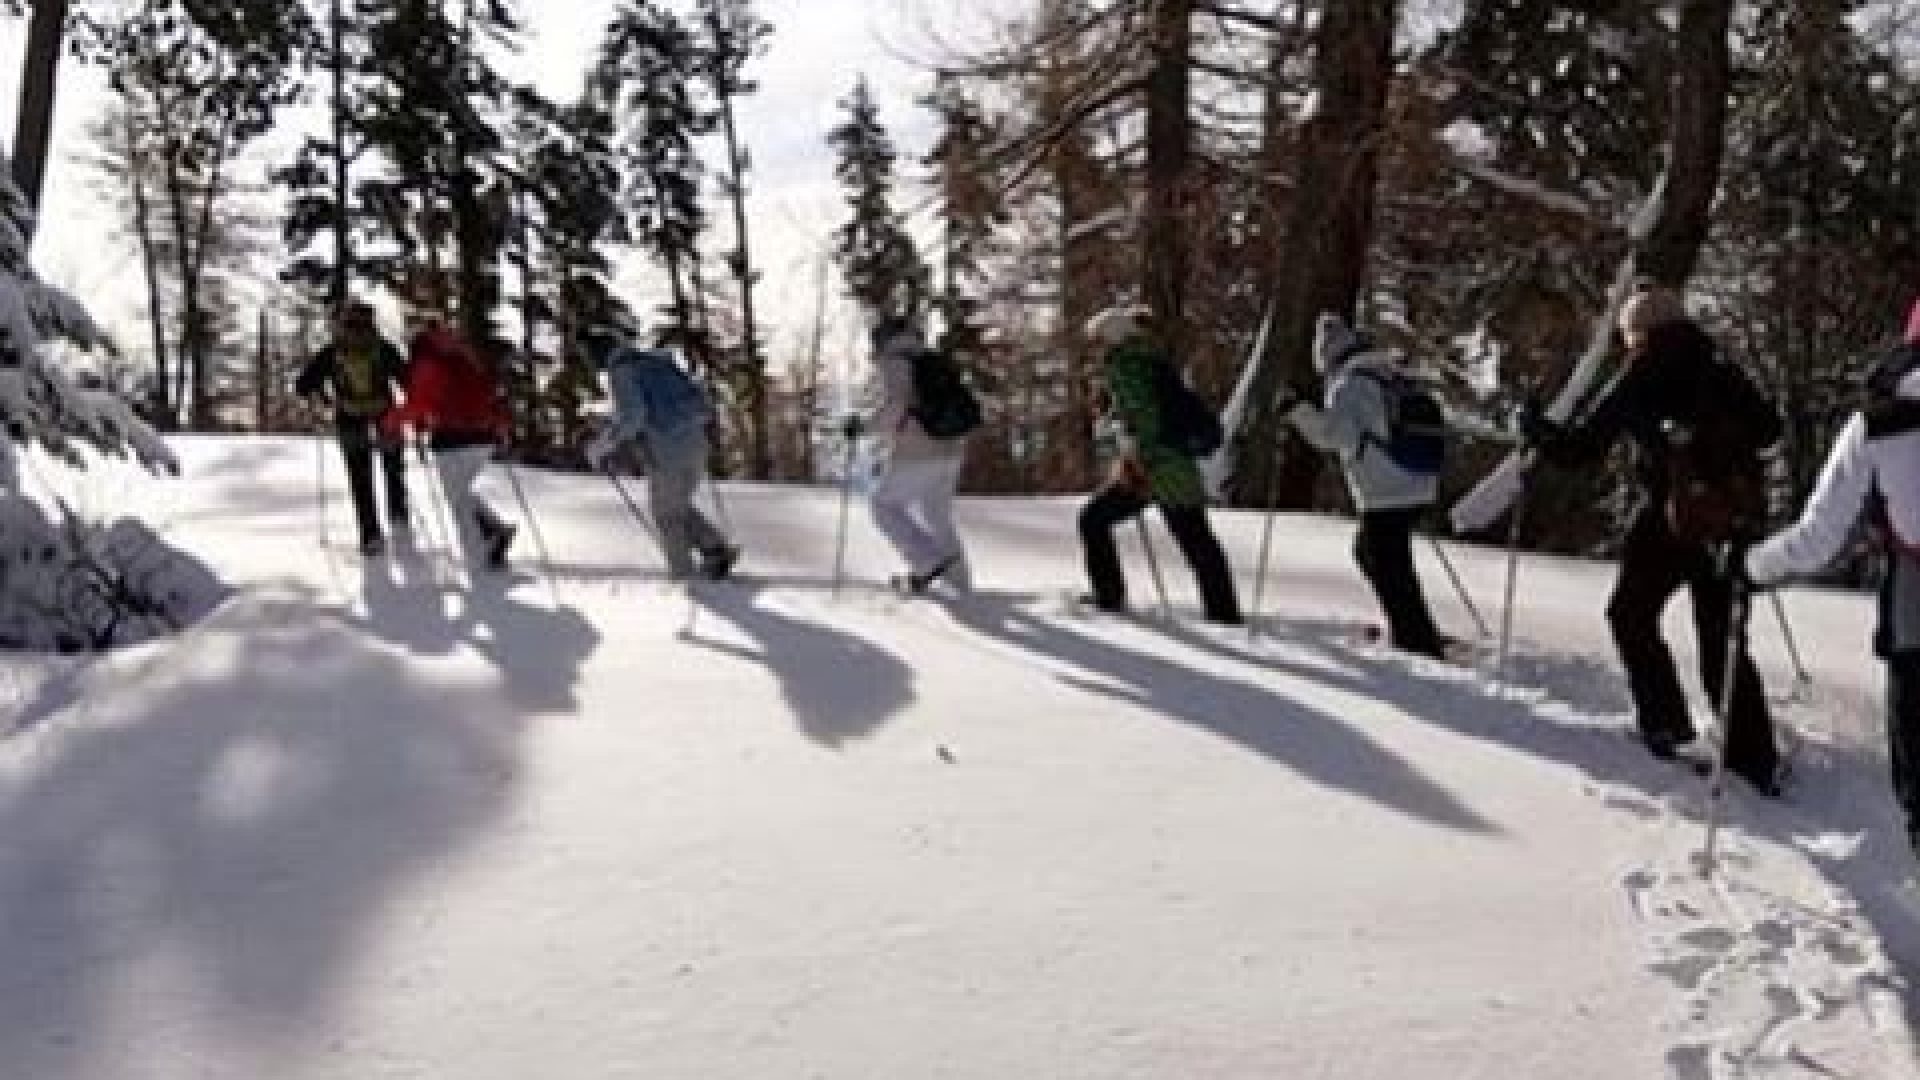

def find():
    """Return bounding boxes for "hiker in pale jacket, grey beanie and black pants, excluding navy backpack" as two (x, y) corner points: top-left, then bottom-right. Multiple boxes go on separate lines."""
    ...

(1286, 313), (1442, 659)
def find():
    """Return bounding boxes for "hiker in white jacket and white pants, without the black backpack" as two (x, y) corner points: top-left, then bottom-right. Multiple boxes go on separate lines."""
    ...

(868, 315), (972, 592)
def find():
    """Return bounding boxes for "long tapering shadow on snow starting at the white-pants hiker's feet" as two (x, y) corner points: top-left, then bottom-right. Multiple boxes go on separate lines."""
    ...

(948, 592), (1498, 832)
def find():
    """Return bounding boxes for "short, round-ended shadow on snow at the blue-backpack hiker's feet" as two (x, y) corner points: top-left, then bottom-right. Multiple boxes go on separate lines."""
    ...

(684, 582), (914, 749)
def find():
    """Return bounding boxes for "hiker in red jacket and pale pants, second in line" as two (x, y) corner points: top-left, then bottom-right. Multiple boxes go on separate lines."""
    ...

(384, 313), (515, 571)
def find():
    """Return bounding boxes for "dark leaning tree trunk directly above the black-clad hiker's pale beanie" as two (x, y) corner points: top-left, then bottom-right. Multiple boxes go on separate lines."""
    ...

(1634, 0), (1734, 288)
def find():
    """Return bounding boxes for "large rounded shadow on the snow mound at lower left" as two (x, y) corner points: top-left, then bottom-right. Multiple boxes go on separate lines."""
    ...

(0, 594), (522, 1080)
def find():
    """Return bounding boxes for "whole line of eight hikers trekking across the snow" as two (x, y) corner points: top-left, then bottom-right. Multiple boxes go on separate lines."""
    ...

(296, 284), (1920, 851)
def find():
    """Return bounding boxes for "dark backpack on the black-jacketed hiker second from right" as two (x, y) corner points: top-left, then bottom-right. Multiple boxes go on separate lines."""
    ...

(1665, 359), (1780, 546)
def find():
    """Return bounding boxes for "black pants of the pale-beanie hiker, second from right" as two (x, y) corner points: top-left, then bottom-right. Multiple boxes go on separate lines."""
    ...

(1607, 507), (1780, 786)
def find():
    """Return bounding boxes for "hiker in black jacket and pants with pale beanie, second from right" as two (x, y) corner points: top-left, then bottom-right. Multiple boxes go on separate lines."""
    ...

(1526, 286), (1782, 796)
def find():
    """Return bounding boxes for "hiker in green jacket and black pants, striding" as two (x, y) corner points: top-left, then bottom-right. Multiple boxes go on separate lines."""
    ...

(1079, 307), (1240, 625)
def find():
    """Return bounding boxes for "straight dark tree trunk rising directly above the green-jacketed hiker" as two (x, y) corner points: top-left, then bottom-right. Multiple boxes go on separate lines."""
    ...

(1140, 0), (1192, 356)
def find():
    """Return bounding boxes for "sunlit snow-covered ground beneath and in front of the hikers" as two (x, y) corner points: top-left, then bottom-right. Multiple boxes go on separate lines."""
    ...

(0, 432), (1920, 1080)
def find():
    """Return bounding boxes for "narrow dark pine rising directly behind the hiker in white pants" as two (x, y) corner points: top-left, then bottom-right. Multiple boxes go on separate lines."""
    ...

(828, 75), (931, 319)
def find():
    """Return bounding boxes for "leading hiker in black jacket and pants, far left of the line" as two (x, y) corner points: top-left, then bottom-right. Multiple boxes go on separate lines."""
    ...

(294, 302), (409, 555)
